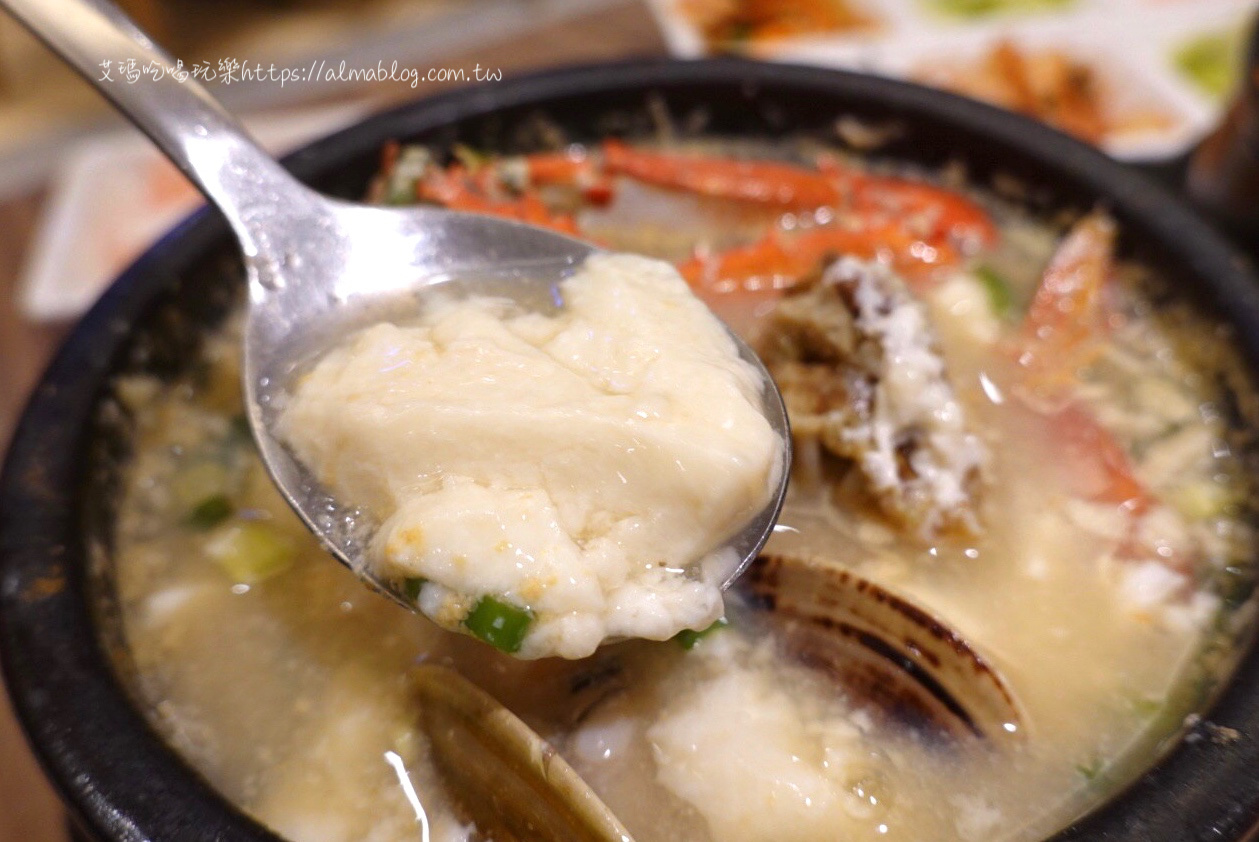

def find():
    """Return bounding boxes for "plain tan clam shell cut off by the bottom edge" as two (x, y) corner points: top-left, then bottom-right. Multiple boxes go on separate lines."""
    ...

(413, 663), (632, 842)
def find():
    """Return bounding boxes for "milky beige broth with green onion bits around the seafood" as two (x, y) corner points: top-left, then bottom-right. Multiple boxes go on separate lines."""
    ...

(105, 147), (1251, 842)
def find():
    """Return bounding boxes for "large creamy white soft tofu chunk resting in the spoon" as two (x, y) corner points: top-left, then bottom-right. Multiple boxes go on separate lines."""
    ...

(282, 254), (781, 657)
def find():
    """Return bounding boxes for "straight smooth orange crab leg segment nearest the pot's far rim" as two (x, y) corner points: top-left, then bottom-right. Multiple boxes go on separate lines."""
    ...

(603, 140), (842, 210)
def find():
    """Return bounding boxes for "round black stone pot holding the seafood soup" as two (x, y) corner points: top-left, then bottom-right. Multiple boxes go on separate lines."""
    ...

(0, 59), (1259, 842)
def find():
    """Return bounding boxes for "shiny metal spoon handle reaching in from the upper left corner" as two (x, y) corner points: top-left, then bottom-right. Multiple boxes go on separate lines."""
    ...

(0, 0), (313, 254)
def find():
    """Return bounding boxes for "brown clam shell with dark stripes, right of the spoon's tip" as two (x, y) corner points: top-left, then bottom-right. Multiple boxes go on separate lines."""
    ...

(738, 554), (1024, 741)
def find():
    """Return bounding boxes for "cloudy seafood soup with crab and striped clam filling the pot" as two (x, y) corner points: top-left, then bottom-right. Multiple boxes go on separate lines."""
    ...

(110, 142), (1254, 842)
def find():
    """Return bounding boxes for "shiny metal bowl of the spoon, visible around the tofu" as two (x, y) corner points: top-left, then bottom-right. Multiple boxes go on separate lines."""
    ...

(243, 200), (791, 610)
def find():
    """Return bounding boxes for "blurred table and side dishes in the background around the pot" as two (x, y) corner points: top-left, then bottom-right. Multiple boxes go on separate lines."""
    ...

(0, 0), (1259, 842)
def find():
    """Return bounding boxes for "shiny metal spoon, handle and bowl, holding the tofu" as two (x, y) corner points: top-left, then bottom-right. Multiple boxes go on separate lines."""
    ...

(0, 0), (789, 609)
